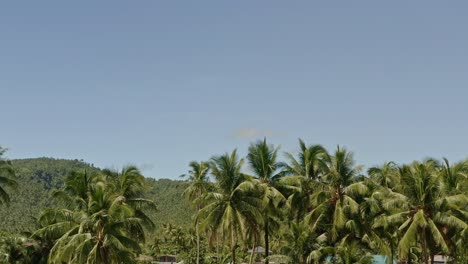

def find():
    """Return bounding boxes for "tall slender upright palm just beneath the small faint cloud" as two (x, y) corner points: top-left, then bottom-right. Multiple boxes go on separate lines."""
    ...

(247, 138), (285, 264)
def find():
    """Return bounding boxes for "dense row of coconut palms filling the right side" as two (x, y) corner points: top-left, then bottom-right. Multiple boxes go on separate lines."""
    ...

(181, 139), (468, 263)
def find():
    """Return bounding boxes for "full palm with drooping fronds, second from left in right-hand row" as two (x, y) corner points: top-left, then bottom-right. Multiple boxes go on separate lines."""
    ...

(199, 150), (262, 264)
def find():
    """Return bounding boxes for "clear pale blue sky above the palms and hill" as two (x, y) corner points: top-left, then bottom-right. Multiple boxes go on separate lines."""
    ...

(0, 0), (468, 178)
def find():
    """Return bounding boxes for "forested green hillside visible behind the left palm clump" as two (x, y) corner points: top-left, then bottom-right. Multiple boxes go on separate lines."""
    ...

(0, 158), (193, 232)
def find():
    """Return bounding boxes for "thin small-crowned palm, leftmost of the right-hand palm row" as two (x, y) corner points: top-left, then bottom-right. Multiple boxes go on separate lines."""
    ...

(183, 161), (210, 264)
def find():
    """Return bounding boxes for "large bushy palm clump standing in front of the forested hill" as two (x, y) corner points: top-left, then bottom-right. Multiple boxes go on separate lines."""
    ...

(34, 169), (152, 263)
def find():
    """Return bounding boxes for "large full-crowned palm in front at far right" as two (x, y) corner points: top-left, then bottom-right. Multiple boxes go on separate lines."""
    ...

(386, 160), (468, 263)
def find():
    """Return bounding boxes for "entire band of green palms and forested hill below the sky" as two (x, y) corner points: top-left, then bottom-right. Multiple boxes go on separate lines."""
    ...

(0, 142), (468, 264)
